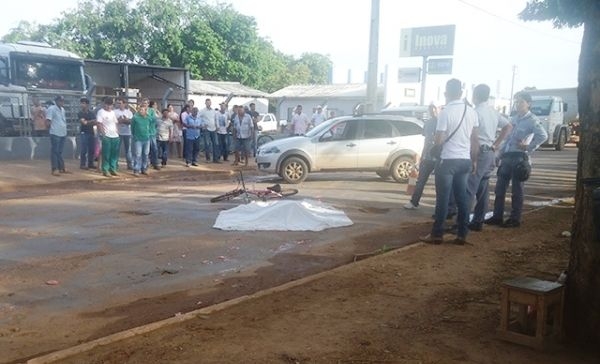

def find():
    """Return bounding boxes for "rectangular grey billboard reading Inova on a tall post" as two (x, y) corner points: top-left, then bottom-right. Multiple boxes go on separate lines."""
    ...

(400, 25), (456, 57)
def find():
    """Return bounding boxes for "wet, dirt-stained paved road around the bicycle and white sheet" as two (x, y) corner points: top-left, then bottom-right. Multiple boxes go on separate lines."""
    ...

(0, 149), (576, 361)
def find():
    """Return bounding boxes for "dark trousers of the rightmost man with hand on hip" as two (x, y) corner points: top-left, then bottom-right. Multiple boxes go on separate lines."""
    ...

(493, 156), (525, 222)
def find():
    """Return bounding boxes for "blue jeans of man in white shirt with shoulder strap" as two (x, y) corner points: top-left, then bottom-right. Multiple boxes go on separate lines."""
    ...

(431, 159), (471, 239)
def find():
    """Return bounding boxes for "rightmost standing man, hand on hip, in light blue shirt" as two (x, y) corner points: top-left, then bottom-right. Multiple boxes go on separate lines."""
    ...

(485, 91), (548, 228)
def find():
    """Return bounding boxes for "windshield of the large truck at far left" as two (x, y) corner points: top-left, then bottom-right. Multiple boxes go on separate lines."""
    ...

(13, 56), (84, 91)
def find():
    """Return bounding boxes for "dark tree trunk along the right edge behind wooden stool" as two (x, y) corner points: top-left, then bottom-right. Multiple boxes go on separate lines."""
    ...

(565, 6), (600, 347)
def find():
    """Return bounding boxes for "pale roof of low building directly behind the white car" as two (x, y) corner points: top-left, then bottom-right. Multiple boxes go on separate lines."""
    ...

(269, 83), (383, 98)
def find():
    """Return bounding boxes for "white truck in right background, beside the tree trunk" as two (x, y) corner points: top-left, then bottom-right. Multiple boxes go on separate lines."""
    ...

(526, 88), (577, 150)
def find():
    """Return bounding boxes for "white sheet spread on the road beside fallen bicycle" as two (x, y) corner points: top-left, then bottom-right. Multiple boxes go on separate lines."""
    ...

(213, 200), (353, 231)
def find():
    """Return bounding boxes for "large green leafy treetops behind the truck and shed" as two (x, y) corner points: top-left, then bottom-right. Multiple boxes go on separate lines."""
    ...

(2, 0), (331, 92)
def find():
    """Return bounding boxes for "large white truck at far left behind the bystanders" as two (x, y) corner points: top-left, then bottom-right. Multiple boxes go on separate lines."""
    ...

(0, 41), (93, 137)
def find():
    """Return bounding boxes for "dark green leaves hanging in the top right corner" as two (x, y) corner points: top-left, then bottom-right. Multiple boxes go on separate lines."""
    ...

(519, 0), (600, 28)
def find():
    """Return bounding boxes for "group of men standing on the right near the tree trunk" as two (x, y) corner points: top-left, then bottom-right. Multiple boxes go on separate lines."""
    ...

(404, 79), (548, 245)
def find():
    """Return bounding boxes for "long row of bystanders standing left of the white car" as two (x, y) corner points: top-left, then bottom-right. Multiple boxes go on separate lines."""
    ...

(42, 96), (282, 177)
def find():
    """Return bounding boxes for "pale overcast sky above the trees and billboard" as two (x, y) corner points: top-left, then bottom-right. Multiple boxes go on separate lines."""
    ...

(0, 0), (583, 103)
